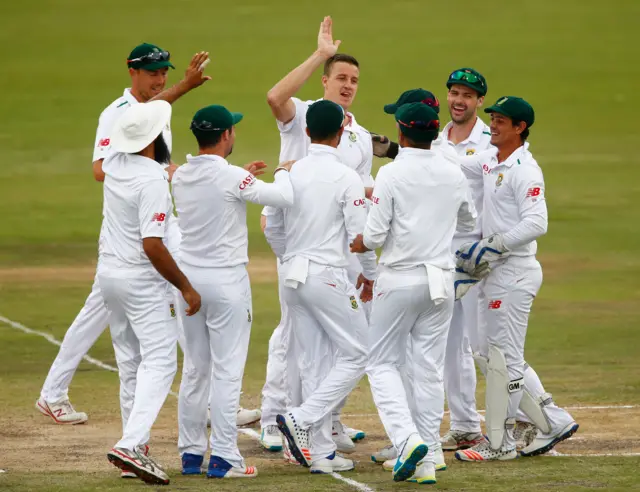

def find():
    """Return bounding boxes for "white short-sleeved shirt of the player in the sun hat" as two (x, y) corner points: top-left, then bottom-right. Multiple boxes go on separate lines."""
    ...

(98, 152), (173, 276)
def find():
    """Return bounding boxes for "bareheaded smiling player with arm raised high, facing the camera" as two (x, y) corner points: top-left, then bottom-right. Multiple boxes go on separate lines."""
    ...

(261, 17), (375, 453)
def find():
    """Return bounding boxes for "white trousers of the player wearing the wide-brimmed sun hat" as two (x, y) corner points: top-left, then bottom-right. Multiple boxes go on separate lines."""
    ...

(98, 267), (178, 450)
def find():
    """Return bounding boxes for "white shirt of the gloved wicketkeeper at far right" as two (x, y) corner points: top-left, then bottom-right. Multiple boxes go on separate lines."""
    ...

(461, 144), (548, 256)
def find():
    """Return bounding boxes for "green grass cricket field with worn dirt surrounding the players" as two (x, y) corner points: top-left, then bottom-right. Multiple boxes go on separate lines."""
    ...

(0, 0), (640, 491)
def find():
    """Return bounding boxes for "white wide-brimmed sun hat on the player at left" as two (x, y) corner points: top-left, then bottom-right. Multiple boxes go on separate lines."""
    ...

(111, 101), (171, 154)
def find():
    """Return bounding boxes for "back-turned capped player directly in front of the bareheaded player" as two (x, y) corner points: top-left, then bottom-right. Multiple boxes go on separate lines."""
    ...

(265, 100), (375, 473)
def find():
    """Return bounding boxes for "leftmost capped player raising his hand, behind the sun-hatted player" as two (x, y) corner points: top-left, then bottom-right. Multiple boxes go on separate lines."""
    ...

(36, 43), (209, 424)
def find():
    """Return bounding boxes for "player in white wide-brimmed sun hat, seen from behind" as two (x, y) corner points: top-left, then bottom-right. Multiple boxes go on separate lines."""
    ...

(98, 101), (200, 485)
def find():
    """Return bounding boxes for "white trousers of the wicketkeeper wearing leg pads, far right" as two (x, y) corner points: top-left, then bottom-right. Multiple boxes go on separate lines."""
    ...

(478, 256), (573, 442)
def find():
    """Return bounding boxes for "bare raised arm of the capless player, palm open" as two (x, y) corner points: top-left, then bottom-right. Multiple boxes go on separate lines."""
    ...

(267, 17), (341, 123)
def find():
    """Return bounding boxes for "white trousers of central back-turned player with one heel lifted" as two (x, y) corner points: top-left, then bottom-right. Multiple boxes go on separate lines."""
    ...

(284, 262), (367, 460)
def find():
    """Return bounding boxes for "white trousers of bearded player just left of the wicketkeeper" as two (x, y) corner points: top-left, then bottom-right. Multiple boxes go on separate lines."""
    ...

(444, 286), (482, 432)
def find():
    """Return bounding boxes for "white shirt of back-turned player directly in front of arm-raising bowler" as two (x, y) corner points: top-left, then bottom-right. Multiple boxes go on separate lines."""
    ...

(265, 144), (376, 279)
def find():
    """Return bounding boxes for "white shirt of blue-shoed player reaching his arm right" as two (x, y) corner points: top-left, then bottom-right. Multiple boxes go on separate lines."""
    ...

(172, 155), (293, 268)
